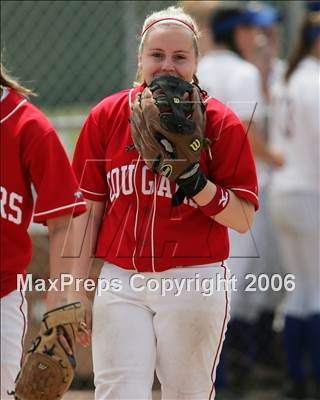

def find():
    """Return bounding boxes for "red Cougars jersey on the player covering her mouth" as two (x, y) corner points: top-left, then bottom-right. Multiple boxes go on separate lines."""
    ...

(73, 86), (258, 272)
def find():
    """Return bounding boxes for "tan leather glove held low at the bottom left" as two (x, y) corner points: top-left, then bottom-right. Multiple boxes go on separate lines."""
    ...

(11, 302), (84, 400)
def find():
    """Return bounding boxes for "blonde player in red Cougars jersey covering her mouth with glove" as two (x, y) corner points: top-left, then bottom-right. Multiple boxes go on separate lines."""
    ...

(73, 7), (258, 400)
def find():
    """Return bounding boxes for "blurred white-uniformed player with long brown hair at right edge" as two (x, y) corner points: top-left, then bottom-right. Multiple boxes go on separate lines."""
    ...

(271, 2), (320, 399)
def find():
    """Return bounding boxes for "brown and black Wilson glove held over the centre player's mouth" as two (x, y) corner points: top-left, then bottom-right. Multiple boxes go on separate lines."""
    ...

(131, 76), (209, 205)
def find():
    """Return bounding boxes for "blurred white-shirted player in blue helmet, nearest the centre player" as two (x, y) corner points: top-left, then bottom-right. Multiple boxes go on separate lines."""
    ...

(198, 5), (282, 390)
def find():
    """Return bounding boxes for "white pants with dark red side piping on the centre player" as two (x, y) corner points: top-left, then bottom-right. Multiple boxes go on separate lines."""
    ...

(92, 264), (230, 400)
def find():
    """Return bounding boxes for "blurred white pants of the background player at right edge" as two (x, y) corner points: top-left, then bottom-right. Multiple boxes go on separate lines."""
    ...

(272, 191), (320, 318)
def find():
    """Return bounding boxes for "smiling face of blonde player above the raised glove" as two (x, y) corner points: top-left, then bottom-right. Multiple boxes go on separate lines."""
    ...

(139, 27), (197, 85)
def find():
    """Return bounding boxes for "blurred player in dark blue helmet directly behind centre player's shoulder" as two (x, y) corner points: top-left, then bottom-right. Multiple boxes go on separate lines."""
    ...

(198, 2), (283, 394)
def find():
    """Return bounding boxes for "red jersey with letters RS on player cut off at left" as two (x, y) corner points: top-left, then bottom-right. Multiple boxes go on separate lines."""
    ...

(0, 90), (85, 297)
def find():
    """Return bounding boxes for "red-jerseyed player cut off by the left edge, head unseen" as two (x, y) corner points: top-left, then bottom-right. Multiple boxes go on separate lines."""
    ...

(0, 65), (85, 399)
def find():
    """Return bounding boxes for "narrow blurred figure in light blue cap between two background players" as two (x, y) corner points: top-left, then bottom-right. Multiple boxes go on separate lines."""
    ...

(244, 2), (286, 371)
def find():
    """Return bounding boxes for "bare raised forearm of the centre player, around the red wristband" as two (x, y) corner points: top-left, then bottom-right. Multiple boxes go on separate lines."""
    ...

(193, 181), (254, 233)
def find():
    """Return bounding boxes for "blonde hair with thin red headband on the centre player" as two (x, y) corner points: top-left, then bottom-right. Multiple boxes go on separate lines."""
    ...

(134, 6), (200, 86)
